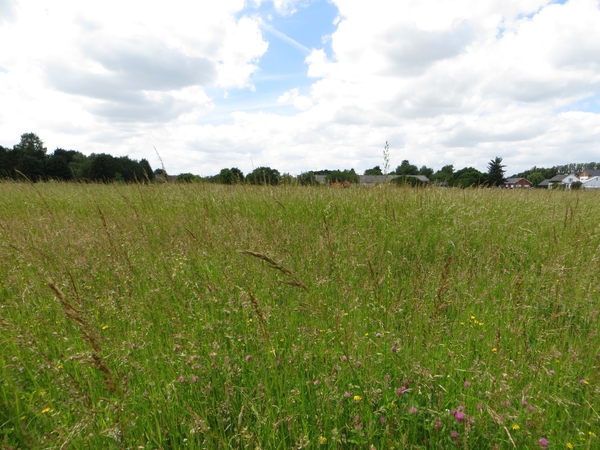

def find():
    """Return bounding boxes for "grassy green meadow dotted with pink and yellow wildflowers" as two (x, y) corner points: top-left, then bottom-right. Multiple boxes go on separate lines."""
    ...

(0, 183), (600, 450)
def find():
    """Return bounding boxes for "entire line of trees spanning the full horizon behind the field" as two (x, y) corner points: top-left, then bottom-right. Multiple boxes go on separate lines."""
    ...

(0, 133), (600, 188)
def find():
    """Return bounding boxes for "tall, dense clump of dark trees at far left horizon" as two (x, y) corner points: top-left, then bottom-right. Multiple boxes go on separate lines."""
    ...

(0, 133), (154, 182)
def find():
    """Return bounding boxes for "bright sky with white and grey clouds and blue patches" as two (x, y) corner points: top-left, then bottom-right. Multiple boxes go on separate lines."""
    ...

(0, 0), (600, 175)
